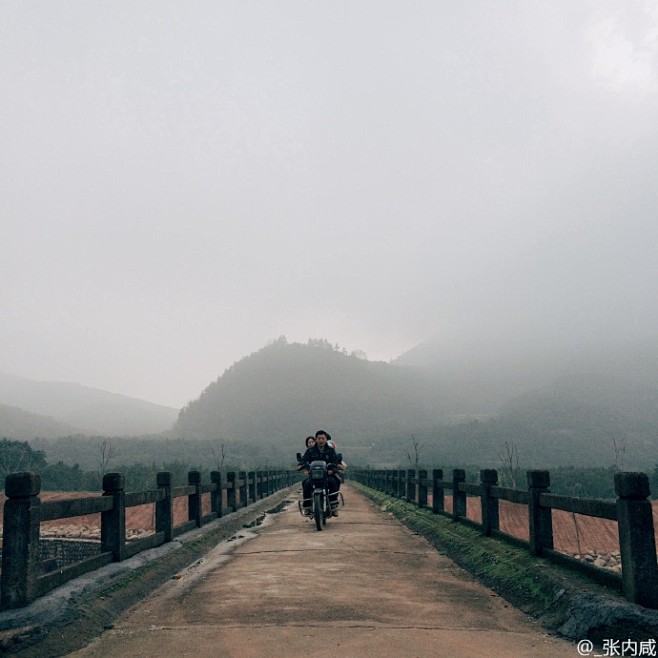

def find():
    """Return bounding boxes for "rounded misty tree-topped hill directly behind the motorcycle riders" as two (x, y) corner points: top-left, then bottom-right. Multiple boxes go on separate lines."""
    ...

(173, 339), (440, 447)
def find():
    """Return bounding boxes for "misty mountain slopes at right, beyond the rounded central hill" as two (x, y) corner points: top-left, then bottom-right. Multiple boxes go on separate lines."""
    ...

(396, 340), (658, 468)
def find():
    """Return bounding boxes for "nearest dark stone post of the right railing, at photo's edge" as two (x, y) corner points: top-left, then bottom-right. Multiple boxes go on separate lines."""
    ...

(615, 473), (658, 608)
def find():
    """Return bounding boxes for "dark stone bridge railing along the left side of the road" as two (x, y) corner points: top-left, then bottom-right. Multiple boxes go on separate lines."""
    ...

(0, 470), (300, 610)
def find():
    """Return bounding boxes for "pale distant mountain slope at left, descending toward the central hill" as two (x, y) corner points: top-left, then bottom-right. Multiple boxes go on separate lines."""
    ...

(0, 373), (178, 436)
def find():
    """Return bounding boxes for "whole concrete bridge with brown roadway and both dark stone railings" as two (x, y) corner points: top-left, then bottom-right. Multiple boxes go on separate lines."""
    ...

(0, 469), (658, 658)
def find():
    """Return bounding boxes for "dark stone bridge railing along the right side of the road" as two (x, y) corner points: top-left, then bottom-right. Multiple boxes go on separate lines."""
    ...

(351, 469), (658, 608)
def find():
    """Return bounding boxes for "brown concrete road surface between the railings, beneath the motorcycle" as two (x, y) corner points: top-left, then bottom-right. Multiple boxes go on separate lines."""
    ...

(71, 485), (578, 658)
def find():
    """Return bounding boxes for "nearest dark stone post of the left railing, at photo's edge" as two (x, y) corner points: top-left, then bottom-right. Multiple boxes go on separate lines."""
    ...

(1, 471), (41, 609)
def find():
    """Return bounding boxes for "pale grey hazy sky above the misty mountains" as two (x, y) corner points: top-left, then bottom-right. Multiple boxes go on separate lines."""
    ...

(0, 0), (658, 406)
